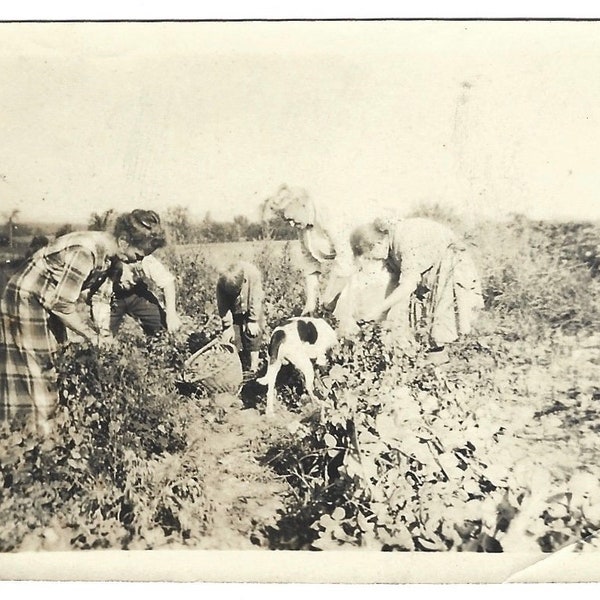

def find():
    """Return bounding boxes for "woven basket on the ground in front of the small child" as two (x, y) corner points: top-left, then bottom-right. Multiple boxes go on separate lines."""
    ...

(183, 339), (242, 394)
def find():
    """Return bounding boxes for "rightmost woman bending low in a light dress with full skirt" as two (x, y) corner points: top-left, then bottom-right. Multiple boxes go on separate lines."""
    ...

(351, 218), (483, 351)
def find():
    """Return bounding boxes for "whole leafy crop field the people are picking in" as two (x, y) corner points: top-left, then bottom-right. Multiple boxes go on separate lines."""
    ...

(0, 214), (600, 552)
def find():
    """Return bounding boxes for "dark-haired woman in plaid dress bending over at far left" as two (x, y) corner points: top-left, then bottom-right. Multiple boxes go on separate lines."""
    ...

(0, 210), (165, 433)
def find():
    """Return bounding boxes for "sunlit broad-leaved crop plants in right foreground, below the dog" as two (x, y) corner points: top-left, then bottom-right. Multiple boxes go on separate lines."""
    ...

(268, 326), (600, 552)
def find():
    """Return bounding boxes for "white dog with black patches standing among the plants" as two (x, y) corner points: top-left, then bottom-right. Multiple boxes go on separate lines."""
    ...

(256, 317), (338, 415)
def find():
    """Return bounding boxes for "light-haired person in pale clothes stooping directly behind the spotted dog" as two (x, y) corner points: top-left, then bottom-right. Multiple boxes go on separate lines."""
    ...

(266, 185), (353, 329)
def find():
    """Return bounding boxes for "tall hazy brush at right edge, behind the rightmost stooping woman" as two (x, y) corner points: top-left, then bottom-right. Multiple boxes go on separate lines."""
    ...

(476, 218), (600, 337)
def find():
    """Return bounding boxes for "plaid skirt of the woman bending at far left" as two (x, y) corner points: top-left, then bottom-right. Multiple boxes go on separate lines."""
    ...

(0, 278), (66, 423)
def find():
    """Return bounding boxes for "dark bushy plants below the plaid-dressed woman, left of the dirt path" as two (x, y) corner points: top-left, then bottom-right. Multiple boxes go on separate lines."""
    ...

(0, 337), (210, 551)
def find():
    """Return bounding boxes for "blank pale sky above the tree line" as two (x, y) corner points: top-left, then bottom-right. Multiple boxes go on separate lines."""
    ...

(0, 22), (600, 222)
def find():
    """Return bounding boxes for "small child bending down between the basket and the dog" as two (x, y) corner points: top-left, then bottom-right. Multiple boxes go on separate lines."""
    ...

(217, 261), (264, 372)
